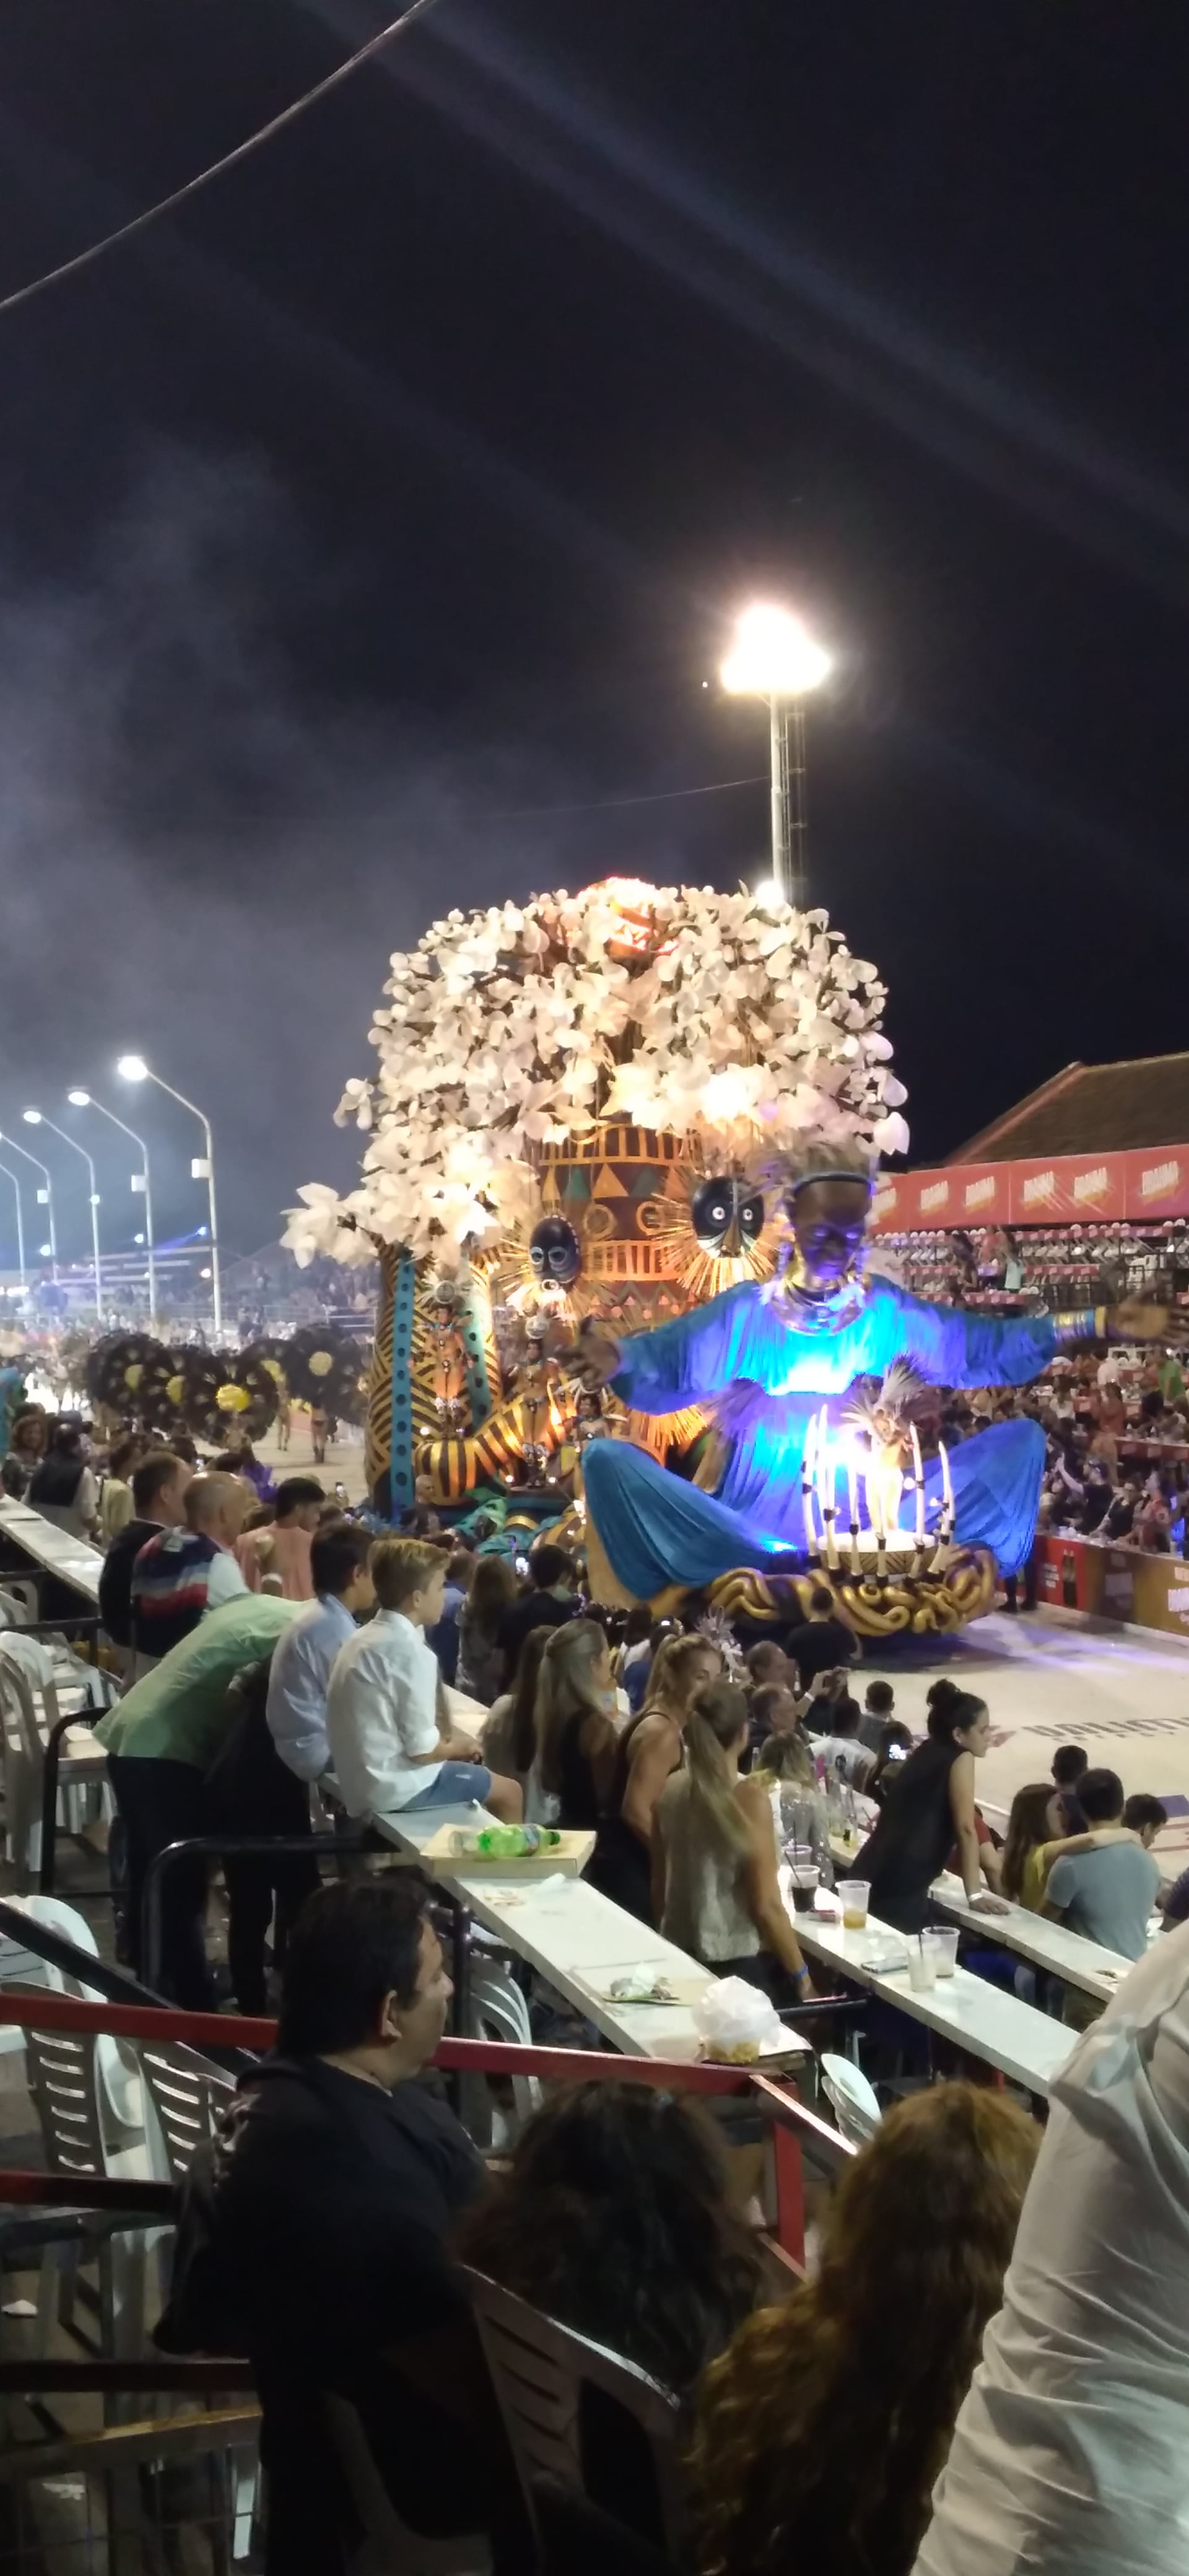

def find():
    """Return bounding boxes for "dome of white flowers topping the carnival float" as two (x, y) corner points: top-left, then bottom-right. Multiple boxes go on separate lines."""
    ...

(285, 881), (908, 1262)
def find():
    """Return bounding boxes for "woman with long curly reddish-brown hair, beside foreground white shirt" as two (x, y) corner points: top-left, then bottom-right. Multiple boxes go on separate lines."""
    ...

(695, 2084), (1040, 2576)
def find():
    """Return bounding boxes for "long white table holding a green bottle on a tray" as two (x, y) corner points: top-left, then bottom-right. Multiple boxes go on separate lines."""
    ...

(373, 1806), (808, 2066)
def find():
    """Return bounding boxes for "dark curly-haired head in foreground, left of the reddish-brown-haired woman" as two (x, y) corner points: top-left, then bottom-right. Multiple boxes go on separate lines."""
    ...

(458, 2084), (759, 2396)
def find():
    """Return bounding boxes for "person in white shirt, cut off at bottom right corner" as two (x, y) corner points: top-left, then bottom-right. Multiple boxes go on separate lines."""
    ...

(913, 1925), (1189, 2576)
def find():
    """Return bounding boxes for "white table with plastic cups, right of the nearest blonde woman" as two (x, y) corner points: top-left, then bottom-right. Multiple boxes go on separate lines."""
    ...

(793, 1914), (1076, 2094)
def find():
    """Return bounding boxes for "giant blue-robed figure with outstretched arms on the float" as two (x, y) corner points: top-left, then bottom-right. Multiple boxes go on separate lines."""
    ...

(572, 1146), (1169, 1599)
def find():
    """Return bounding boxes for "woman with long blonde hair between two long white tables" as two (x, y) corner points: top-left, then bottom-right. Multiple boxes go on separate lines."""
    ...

(651, 1682), (808, 2001)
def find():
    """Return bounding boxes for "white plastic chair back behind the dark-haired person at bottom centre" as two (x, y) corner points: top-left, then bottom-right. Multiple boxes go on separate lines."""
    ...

(466, 2272), (684, 2563)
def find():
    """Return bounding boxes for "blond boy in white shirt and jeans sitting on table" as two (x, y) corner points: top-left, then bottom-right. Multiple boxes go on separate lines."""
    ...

(327, 1538), (525, 1824)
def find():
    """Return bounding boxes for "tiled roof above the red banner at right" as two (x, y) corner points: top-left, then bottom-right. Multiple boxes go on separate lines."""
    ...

(947, 1053), (1189, 1162)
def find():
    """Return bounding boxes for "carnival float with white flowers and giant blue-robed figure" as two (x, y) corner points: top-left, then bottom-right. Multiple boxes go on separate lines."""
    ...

(283, 879), (1042, 1636)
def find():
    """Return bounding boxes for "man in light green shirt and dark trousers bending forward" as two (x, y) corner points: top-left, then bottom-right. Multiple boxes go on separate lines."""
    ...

(95, 1592), (301, 2012)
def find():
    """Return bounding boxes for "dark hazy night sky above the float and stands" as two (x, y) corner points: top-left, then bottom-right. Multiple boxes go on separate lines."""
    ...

(0, 0), (1189, 1250)
